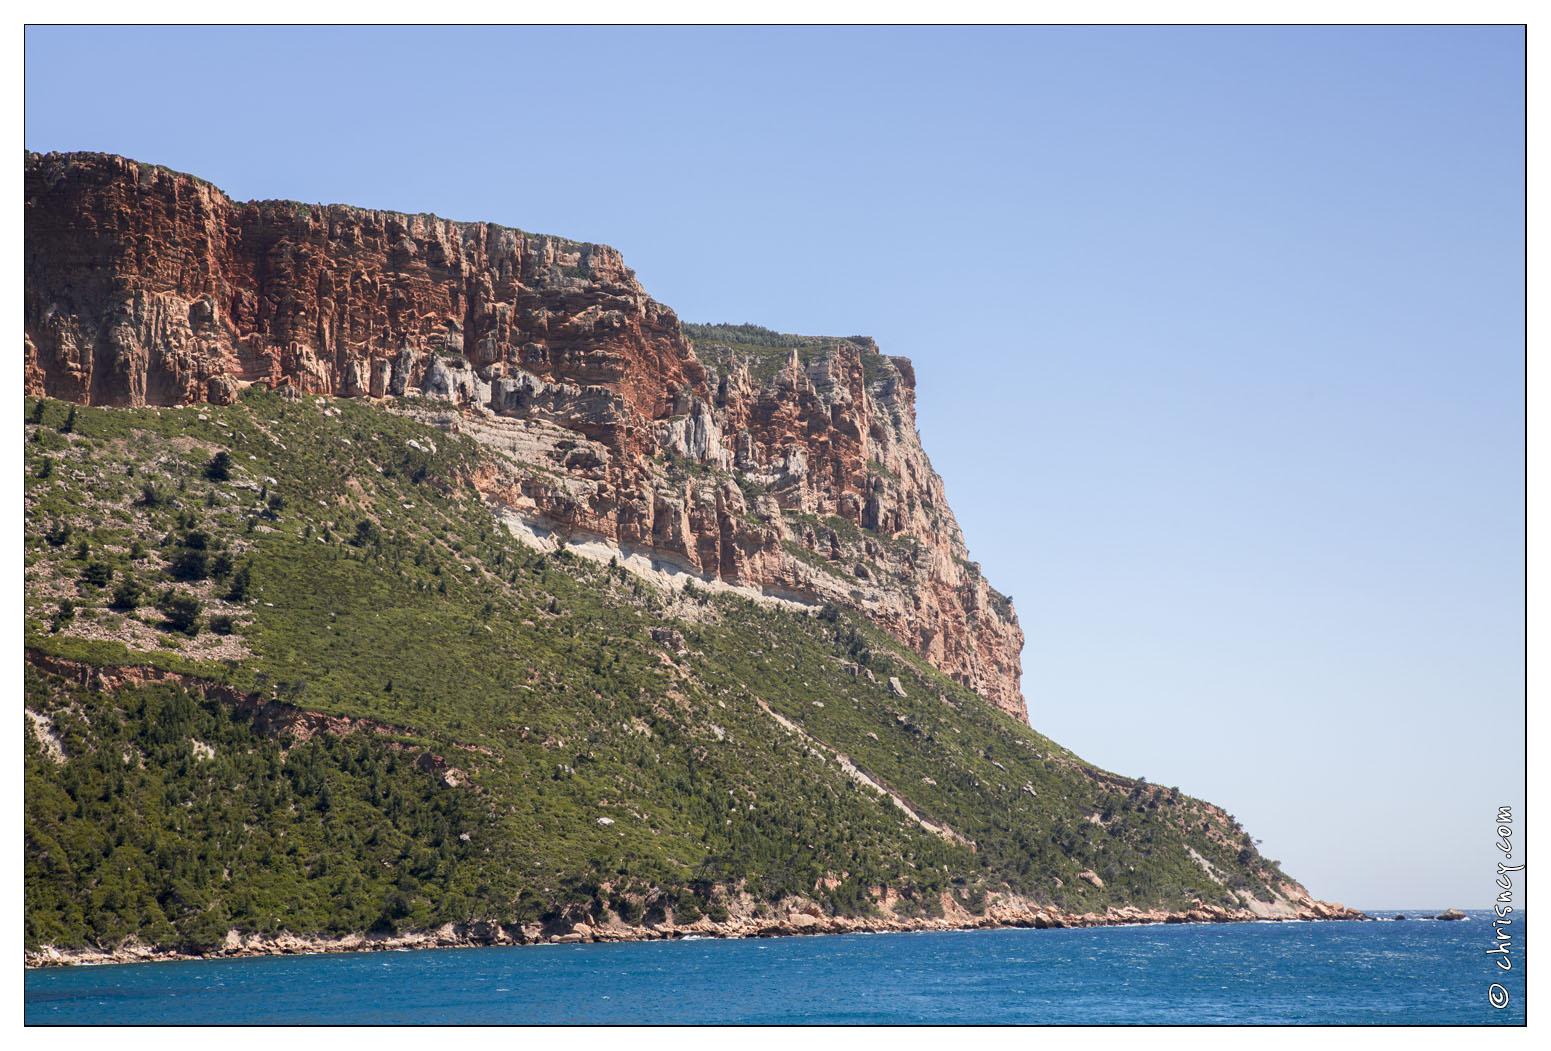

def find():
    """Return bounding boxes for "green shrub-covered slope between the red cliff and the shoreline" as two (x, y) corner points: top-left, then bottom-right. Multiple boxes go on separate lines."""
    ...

(25, 389), (1281, 949)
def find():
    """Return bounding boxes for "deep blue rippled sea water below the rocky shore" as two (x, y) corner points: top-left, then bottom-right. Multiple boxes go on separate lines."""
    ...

(26, 911), (1525, 1025)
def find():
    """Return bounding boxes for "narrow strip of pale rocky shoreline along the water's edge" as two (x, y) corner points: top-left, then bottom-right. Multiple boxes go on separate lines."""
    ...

(23, 898), (1368, 967)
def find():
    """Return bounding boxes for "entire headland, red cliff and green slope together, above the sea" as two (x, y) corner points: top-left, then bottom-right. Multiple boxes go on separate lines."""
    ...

(25, 155), (1354, 963)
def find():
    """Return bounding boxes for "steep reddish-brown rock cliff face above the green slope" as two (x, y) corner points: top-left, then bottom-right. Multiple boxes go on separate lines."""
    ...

(23, 153), (1027, 718)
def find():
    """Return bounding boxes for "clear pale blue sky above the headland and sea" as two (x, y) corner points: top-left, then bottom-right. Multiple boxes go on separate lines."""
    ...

(26, 28), (1525, 908)
